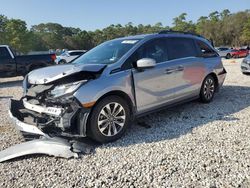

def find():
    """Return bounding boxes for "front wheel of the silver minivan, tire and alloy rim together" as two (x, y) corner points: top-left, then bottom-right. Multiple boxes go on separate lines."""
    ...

(88, 96), (131, 143)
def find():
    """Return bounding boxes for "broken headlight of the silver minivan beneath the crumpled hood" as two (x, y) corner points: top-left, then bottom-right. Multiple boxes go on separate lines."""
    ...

(50, 80), (88, 98)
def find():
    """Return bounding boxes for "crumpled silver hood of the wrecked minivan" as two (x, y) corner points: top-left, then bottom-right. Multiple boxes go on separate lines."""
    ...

(28, 64), (106, 85)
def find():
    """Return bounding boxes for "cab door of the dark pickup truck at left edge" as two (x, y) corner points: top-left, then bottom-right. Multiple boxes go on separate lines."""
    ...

(0, 47), (16, 77)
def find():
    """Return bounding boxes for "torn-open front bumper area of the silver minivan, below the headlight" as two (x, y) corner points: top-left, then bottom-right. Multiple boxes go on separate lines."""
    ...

(10, 96), (89, 137)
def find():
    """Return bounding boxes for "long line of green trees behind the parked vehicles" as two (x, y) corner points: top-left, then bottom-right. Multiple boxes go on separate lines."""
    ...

(0, 9), (250, 53)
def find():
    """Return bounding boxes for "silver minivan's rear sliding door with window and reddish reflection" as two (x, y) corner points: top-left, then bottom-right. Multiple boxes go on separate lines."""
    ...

(164, 37), (206, 100)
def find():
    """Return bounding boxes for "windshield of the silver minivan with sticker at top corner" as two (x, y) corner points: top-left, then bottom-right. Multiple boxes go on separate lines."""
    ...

(73, 39), (139, 64)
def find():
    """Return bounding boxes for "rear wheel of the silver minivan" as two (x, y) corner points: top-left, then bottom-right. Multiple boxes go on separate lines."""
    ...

(200, 75), (216, 103)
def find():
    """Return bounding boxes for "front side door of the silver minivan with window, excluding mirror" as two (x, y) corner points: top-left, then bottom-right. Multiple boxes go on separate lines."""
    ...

(128, 38), (179, 113)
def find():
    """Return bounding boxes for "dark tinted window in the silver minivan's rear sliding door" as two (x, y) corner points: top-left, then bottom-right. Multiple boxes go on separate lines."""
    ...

(167, 38), (198, 60)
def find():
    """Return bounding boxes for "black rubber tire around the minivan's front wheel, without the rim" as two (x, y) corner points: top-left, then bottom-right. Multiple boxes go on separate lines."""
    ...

(87, 96), (131, 143)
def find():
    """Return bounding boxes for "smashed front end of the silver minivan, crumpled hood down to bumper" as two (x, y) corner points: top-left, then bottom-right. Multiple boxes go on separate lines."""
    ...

(10, 65), (104, 137)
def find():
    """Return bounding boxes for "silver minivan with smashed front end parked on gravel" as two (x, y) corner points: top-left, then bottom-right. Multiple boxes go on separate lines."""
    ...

(10, 31), (226, 143)
